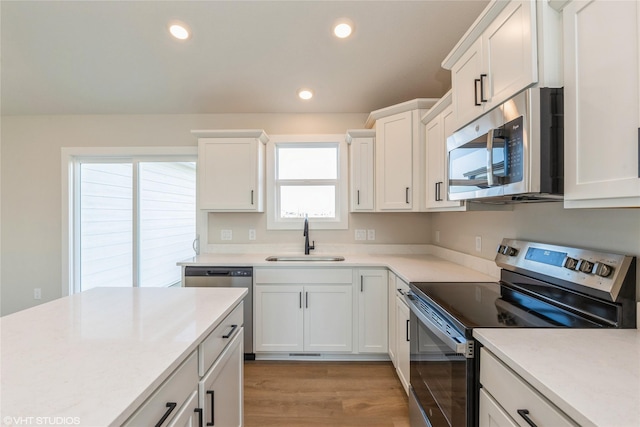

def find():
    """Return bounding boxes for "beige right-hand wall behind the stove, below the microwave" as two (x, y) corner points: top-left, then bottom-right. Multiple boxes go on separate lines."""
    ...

(429, 202), (640, 301)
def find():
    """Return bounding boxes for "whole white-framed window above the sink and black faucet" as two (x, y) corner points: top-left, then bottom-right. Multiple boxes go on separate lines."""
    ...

(267, 135), (348, 229)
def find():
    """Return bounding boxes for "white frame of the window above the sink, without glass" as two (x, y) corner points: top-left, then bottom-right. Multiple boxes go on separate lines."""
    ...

(266, 134), (349, 230)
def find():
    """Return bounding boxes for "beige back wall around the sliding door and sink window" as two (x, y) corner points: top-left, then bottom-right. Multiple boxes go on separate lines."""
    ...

(0, 114), (429, 315)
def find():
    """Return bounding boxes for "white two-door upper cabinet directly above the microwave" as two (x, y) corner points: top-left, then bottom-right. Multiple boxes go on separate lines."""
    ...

(442, 0), (562, 129)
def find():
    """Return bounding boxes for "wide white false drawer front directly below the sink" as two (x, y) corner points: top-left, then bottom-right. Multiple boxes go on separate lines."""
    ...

(254, 268), (353, 285)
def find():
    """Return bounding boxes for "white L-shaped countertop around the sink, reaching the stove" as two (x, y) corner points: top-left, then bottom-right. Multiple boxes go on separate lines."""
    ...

(178, 253), (497, 282)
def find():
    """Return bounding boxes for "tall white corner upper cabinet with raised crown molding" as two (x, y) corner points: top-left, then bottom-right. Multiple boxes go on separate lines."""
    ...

(367, 98), (437, 212)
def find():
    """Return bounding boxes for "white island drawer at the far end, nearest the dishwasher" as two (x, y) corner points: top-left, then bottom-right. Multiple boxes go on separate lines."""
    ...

(198, 302), (244, 377)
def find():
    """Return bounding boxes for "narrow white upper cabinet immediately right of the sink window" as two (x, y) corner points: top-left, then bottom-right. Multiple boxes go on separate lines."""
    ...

(346, 129), (376, 212)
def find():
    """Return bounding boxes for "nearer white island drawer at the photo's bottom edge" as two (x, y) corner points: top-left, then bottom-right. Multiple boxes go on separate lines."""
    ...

(123, 351), (198, 427)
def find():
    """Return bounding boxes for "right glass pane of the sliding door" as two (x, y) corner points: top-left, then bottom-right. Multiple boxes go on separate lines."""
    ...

(139, 162), (196, 287)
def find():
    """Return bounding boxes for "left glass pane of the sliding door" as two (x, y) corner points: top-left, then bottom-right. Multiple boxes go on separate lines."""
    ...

(79, 163), (133, 291)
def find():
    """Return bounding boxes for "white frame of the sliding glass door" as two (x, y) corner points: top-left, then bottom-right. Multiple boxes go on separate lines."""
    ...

(61, 147), (203, 296)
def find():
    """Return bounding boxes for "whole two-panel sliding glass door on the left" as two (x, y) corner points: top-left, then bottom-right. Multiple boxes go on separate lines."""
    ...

(67, 147), (196, 293)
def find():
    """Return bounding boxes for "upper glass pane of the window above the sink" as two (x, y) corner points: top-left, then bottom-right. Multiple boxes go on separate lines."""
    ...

(277, 146), (338, 179)
